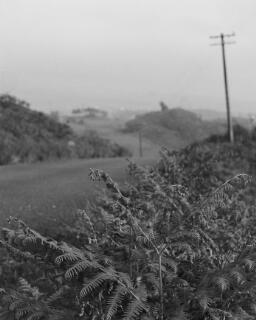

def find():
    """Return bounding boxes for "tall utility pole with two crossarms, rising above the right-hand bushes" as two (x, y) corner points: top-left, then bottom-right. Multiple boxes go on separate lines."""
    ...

(210, 33), (235, 143)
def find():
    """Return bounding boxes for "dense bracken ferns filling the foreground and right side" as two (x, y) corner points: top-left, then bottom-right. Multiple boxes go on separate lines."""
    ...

(0, 124), (256, 320)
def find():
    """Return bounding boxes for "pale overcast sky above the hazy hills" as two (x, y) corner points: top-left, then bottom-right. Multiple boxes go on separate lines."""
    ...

(0, 0), (256, 113)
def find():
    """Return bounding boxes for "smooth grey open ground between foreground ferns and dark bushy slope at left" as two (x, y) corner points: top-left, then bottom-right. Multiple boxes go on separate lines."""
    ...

(0, 158), (156, 231)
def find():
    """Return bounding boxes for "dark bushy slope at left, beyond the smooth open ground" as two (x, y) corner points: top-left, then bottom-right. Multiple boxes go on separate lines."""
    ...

(0, 95), (129, 165)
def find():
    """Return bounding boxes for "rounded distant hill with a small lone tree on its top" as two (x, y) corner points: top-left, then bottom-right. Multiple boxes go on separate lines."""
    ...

(125, 108), (224, 149)
